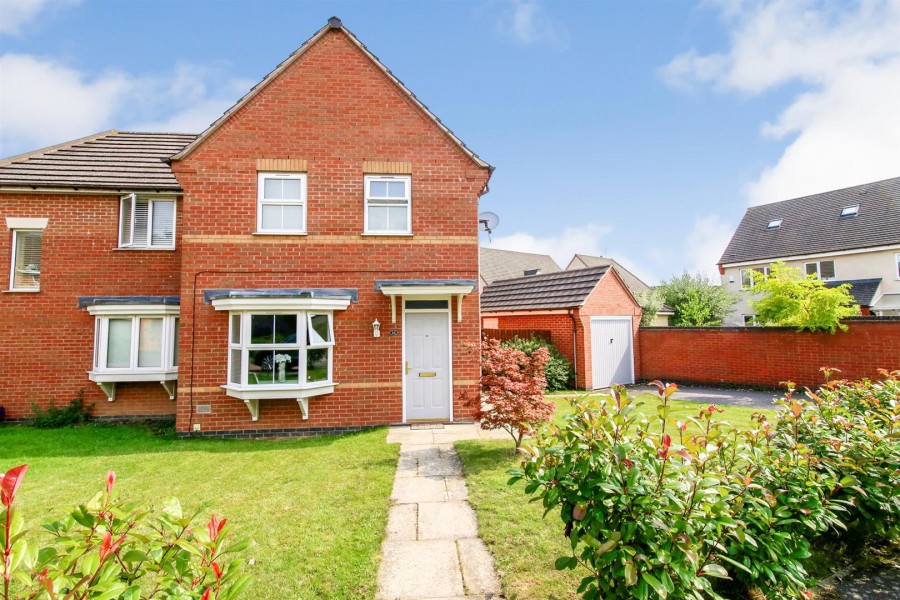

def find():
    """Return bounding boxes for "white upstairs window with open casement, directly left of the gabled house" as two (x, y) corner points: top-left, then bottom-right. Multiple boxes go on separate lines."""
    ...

(119, 194), (175, 250)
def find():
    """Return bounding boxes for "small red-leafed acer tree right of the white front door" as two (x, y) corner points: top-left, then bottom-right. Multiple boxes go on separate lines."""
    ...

(466, 337), (556, 449)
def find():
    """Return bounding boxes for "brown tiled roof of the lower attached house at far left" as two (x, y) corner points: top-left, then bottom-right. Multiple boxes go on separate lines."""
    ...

(0, 129), (197, 192)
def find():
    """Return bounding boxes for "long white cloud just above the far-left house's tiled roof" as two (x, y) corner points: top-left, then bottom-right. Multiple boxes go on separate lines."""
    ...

(0, 54), (251, 156)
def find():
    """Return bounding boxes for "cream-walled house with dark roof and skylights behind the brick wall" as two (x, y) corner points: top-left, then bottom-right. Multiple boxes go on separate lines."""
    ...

(719, 177), (900, 325)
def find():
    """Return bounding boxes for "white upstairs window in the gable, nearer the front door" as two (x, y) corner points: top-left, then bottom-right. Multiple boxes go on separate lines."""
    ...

(364, 175), (412, 235)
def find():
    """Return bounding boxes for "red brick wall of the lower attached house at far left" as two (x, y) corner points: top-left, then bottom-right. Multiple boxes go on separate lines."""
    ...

(0, 194), (182, 419)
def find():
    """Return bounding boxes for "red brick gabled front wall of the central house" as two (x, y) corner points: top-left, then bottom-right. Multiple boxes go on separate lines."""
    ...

(173, 31), (488, 431)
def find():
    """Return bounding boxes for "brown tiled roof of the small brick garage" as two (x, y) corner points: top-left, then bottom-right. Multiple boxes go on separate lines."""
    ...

(481, 267), (609, 312)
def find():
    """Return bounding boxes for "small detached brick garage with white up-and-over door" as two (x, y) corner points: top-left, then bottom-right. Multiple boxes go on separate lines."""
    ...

(481, 266), (641, 389)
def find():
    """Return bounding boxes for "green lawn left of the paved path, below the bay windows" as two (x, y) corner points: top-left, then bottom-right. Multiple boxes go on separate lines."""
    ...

(0, 426), (398, 600)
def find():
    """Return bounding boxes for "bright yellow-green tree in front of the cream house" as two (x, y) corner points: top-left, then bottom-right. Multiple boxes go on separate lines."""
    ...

(750, 262), (859, 333)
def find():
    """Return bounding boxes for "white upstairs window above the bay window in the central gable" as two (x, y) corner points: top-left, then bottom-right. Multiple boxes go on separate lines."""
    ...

(256, 173), (306, 234)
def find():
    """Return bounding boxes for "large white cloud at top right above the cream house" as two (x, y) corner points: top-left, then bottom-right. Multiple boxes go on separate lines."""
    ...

(661, 0), (900, 204)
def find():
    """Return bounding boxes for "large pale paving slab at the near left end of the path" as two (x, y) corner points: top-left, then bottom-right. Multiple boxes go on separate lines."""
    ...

(376, 539), (465, 600)
